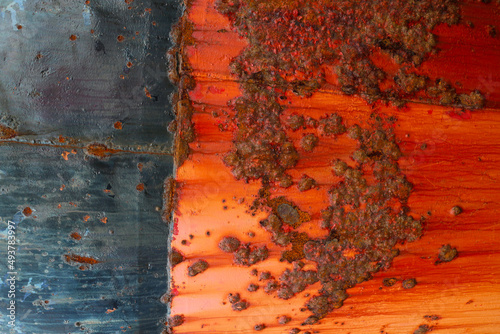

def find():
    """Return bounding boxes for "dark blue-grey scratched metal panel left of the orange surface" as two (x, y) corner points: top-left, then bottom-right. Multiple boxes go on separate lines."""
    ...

(0, 0), (180, 333)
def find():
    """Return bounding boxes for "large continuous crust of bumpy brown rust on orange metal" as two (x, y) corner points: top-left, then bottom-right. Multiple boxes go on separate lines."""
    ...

(207, 0), (492, 325)
